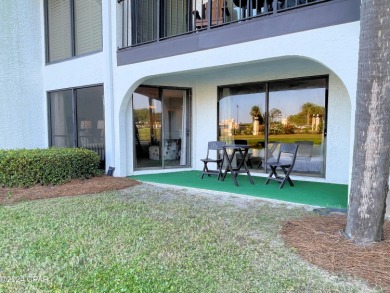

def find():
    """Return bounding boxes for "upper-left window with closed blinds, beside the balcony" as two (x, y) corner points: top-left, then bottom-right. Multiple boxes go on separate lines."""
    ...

(46, 0), (102, 62)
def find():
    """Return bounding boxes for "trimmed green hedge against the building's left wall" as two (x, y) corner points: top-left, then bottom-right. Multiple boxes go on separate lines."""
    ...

(0, 148), (102, 187)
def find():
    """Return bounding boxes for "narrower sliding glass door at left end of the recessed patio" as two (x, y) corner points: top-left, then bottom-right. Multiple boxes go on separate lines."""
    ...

(133, 86), (190, 169)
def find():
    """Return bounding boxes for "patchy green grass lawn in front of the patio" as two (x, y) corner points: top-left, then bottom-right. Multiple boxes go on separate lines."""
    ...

(0, 184), (370, 292)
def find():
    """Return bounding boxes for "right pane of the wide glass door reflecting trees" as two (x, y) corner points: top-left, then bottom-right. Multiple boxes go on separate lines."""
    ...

(268, 78), (327, 176)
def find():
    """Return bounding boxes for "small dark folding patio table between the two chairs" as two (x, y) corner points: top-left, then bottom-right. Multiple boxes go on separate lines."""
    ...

(222, 144), (254, 186)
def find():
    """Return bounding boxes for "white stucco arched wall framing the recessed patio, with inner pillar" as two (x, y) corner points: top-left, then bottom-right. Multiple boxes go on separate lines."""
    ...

(114, 22), (359, 183)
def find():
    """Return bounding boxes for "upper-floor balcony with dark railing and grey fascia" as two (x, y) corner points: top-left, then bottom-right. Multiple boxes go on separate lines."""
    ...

(117, 0), (360, 66)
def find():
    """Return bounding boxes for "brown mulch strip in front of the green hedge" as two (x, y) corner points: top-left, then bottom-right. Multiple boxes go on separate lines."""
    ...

(0, 176), (140, 204)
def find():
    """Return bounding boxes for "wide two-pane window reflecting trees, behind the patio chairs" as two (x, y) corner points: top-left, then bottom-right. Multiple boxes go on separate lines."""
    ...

(218, 77), (328, 177)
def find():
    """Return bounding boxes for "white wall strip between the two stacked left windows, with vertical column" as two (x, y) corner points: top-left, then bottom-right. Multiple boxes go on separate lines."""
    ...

(42, 0), (114, 167)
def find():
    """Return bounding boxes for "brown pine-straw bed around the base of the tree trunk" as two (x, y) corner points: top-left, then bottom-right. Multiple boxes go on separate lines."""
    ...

(281, 214), (390, 292)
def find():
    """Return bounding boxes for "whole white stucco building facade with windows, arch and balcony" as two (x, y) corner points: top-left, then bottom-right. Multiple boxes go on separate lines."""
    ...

(0, 0), (360, 184)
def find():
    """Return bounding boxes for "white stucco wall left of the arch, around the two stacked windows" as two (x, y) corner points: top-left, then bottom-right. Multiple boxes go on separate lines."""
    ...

(0, 0), (116, 167)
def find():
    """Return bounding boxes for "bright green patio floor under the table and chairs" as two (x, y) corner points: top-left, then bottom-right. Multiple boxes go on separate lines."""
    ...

(130, 171), (348, 209)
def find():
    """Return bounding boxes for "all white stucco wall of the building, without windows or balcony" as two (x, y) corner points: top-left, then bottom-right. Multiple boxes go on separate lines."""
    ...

(0, 0), (359, 183)
